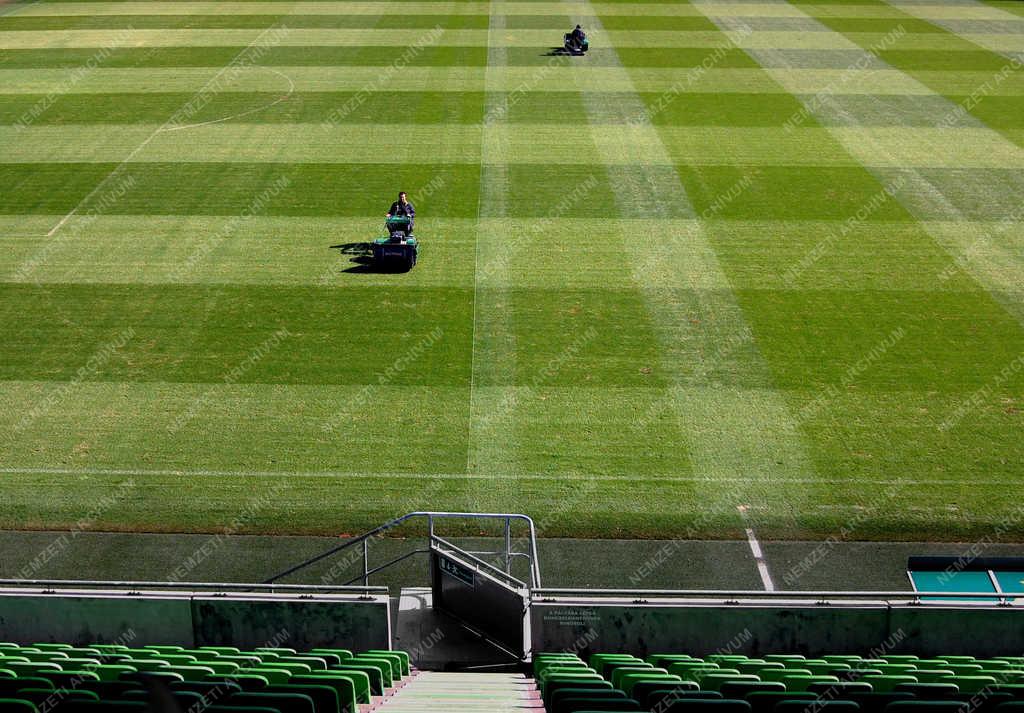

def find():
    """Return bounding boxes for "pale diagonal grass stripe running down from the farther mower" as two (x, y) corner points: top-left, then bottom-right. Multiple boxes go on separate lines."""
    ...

(584, 4), (813, 506)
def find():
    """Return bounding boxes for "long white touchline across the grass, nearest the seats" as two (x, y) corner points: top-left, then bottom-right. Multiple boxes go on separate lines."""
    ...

(0, 466), (1021, 487)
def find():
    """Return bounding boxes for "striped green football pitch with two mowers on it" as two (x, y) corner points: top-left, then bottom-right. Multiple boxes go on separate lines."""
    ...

(0, 0), (1024, 541)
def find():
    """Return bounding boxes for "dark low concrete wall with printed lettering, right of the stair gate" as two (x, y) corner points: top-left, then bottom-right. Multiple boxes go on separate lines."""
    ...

(530, 601), (1024, 656)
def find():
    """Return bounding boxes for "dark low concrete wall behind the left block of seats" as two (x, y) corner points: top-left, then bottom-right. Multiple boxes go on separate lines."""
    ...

(0, 590), (390, 649)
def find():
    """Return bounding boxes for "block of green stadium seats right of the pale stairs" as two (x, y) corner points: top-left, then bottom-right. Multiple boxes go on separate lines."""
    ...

(534, 654), (1024, 713)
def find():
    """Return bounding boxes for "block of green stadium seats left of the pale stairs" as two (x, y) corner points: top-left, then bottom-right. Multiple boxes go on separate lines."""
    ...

(0, 642), (412, 713)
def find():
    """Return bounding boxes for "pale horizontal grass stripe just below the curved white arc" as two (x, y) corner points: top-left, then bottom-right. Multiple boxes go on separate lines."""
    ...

(14, 123), (1024, 166)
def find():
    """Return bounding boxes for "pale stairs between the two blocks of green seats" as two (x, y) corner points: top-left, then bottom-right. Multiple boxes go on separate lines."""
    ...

(374, 671), (544, 713)
